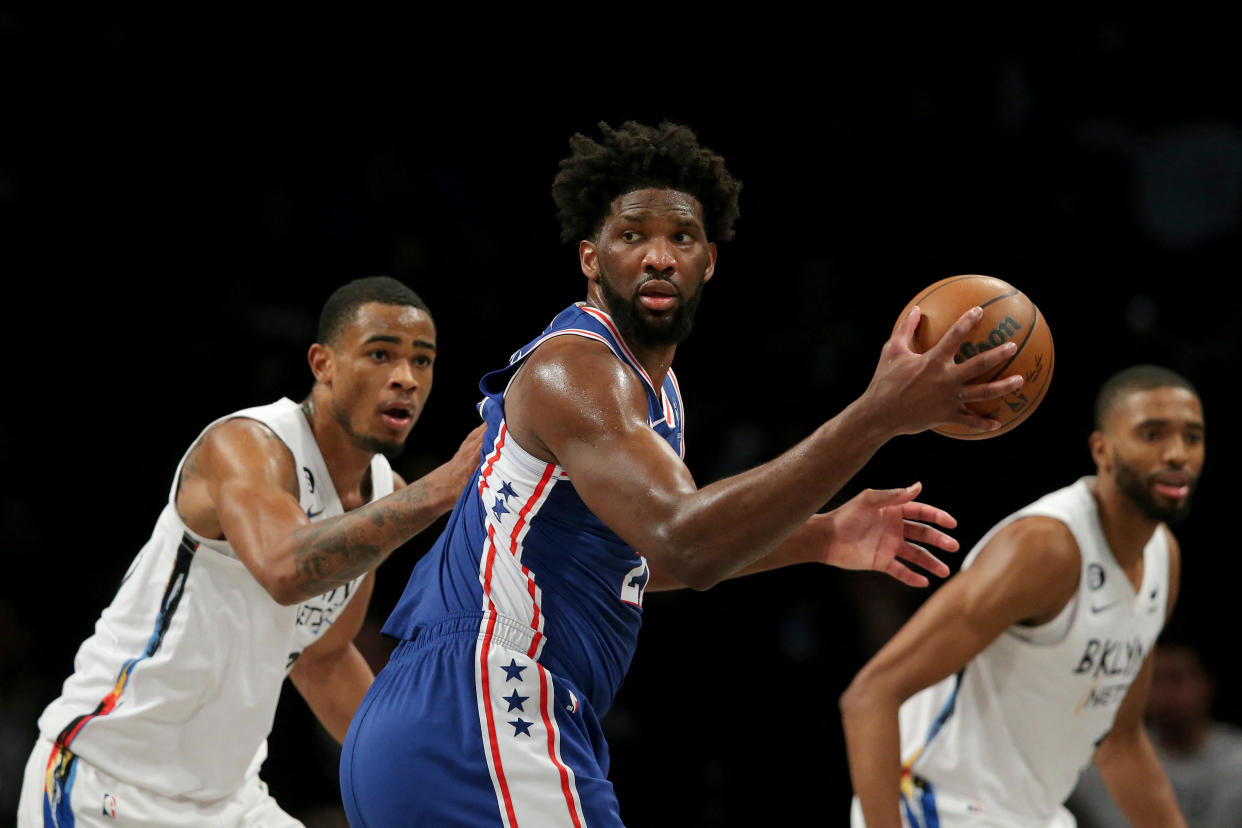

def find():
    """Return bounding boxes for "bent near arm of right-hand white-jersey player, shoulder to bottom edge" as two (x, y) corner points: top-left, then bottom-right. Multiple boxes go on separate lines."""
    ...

(841, 518), (1081, 828)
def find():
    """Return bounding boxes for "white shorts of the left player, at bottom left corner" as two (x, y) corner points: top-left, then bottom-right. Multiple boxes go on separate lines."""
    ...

(17, 739), (304, 828)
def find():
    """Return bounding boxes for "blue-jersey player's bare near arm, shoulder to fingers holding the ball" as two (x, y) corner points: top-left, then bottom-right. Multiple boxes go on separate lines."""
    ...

(505, 307), (1021, 588)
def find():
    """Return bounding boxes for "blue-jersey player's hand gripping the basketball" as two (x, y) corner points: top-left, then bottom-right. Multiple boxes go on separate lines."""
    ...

(861, 307), (1023, 434)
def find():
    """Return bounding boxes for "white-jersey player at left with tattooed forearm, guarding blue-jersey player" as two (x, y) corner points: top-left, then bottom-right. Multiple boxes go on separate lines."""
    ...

(17, 277), (482, 828)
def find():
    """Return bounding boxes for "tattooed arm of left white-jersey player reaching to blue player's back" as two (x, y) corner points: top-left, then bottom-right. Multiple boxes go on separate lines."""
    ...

(178, 418), (483, 605)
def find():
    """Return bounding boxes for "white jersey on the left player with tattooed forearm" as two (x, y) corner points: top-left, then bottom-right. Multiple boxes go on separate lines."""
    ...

(39, 400), (392, 802)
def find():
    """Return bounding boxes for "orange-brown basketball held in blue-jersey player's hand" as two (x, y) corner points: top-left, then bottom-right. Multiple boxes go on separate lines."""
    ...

(894, 274), (1054, 439)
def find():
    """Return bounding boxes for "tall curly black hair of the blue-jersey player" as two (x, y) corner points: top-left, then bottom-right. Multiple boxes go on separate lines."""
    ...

(551, 120), (741, 242)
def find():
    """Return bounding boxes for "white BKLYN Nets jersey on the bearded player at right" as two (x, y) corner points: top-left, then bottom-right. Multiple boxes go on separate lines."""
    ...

(900, 478), (1169, 826)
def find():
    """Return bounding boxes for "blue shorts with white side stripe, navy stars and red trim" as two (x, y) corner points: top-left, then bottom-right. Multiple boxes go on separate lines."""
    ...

(340, 613), (622, 828)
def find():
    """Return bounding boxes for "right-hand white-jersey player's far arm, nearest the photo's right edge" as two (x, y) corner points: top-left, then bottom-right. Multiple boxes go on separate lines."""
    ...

(1095, 528), (1186, 828)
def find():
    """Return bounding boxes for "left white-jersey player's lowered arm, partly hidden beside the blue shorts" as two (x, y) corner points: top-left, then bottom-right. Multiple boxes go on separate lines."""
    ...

(289, 572), (375, 742)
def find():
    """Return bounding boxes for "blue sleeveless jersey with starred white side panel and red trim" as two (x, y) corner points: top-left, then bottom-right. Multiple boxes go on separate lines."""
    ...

(384, 304), (683, 715)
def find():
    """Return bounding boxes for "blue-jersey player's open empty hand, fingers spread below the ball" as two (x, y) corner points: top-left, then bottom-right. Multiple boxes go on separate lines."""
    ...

(823, 483), (959, 586)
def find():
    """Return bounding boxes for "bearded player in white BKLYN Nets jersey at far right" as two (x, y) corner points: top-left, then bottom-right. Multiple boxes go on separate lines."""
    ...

(841, 365), (1203, 828)
